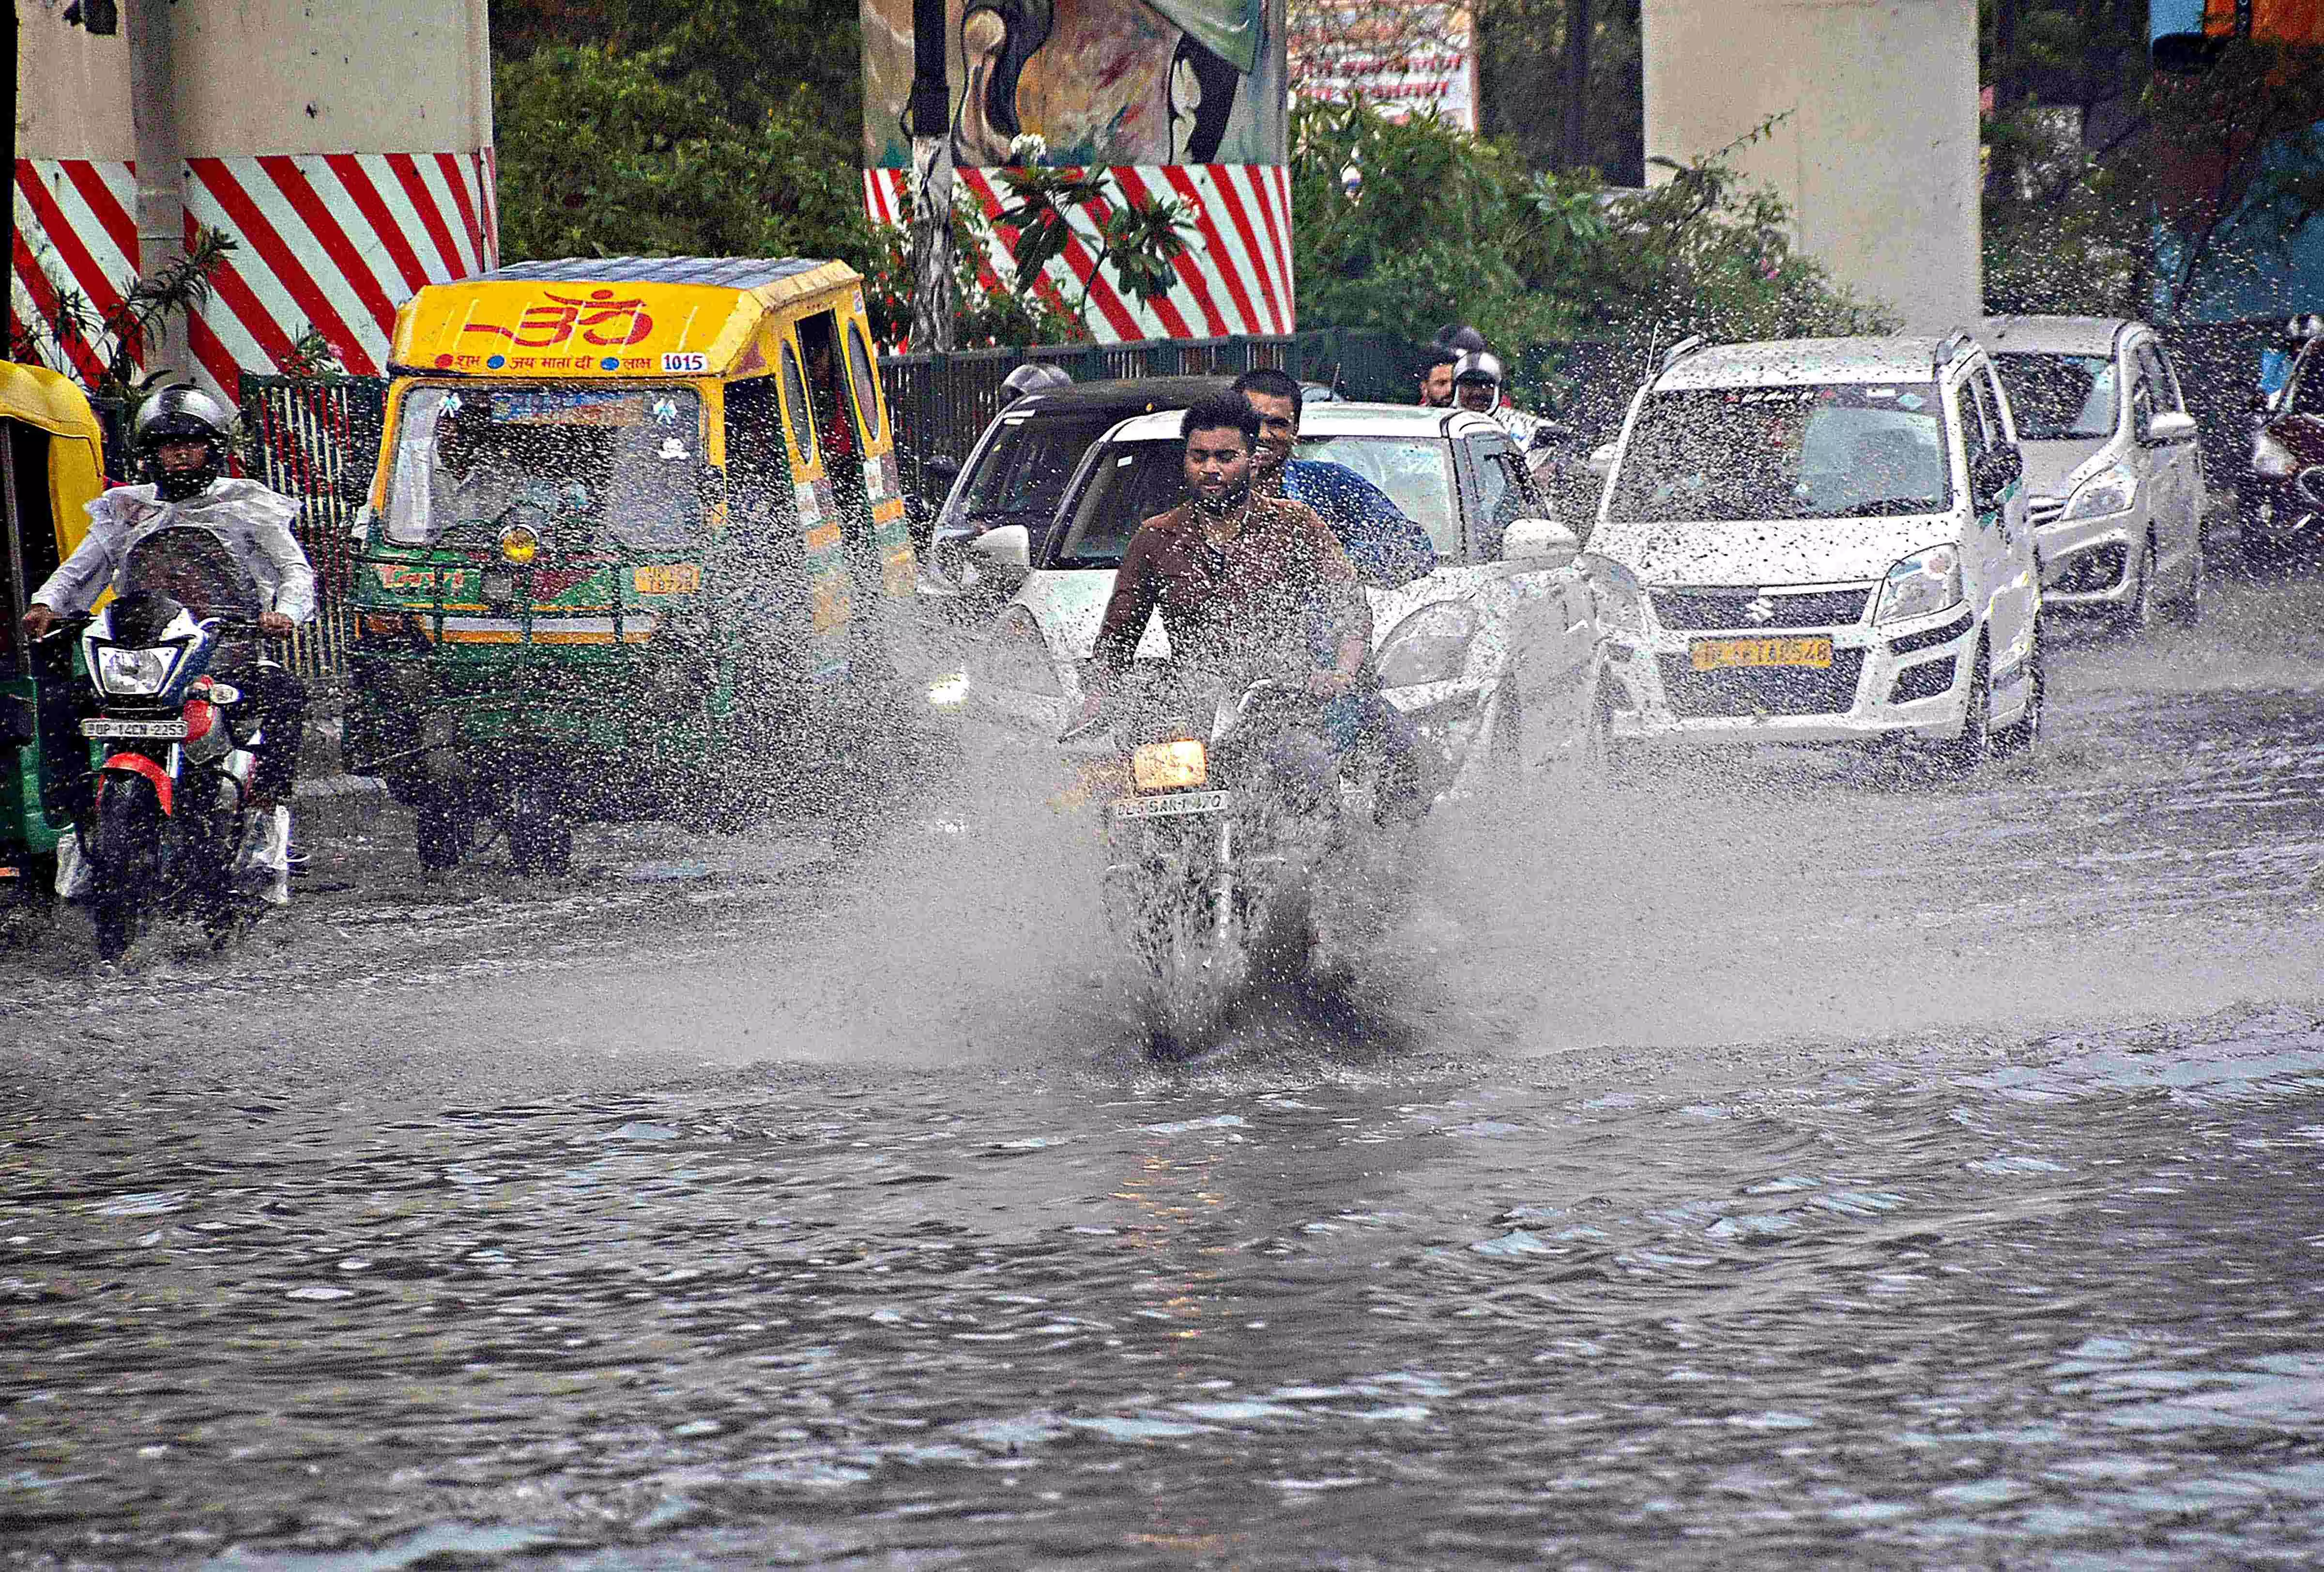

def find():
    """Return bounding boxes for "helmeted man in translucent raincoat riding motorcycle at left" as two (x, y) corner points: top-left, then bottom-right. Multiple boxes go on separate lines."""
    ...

(23, 386), (314, 905)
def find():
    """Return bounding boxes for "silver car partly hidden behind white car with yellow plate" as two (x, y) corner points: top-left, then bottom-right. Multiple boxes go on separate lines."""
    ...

(1978, 316), (2203, 628)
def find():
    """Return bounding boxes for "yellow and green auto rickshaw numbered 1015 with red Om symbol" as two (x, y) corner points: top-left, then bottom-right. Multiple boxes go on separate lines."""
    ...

(344, 258), (918, 872)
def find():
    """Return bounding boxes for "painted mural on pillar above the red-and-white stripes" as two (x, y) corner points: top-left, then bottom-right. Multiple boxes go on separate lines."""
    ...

(862, 0), (1285, 170)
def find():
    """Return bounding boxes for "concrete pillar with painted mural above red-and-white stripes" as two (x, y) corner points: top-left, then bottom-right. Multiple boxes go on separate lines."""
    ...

(862, 0), (1297, 342)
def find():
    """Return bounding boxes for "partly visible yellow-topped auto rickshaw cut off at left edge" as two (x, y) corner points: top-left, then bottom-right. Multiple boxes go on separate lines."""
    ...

(0, 363), (105, 905)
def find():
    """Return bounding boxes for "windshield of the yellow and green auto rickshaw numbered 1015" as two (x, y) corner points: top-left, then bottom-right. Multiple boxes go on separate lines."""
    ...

(388, 386), (702, 551)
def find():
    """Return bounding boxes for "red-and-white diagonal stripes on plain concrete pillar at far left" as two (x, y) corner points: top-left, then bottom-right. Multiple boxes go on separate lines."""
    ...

(9, 149), (500, 400)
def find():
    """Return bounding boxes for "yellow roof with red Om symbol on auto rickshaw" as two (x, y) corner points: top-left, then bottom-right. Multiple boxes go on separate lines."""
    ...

(388, 256), (862, 377)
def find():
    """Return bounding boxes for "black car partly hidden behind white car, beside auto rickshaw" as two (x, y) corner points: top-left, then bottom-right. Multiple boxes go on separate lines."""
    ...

(920, 377), (1234, 598)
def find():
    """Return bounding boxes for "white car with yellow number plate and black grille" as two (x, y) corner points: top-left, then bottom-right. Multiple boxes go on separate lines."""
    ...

(1590, 333), (2043, 768)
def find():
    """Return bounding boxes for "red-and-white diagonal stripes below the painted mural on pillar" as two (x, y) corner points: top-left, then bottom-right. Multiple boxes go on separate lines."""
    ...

(865, 163), (1299, 344)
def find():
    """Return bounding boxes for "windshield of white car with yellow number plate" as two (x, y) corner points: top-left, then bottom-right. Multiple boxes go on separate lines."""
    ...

(1608, 381), (1952, 523)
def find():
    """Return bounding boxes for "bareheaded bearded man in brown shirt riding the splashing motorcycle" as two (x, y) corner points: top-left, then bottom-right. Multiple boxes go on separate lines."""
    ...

(1074, 393), (1413, 818)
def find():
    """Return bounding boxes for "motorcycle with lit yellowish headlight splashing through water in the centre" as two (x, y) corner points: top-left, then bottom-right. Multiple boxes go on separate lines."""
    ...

(1083, 679), (1378, 1058)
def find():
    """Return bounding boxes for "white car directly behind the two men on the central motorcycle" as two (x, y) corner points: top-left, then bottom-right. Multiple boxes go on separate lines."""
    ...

(950, 402), (1634, 779)
